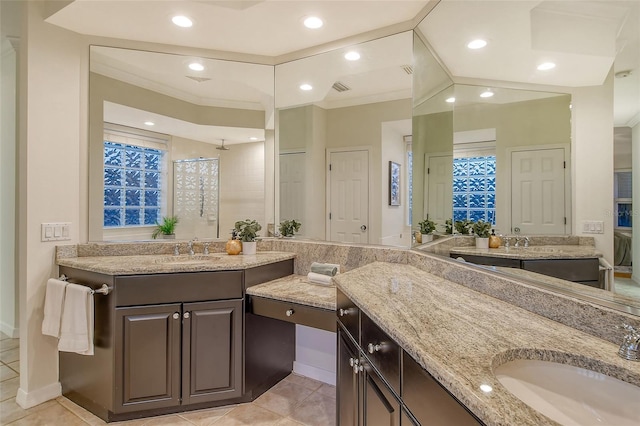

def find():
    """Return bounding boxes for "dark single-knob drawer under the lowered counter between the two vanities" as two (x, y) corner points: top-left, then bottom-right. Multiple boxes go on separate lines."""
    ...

(248, 296), (337, 331)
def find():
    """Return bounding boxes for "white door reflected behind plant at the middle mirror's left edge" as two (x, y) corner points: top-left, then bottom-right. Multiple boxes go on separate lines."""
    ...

(280, 152), (306, 228)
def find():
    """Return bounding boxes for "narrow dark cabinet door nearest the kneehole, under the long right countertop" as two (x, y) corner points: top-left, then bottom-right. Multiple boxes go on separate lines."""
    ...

(336, 326), (360, 426)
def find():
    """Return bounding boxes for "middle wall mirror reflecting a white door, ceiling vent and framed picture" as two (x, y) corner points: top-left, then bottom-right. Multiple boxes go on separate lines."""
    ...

(275, 31), (413, 247)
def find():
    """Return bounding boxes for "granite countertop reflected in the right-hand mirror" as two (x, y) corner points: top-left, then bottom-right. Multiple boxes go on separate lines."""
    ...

(450, 245), (602, 260)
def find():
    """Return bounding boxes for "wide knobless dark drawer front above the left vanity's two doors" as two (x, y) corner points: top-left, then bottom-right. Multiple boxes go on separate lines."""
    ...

(114, 271), (242, 306)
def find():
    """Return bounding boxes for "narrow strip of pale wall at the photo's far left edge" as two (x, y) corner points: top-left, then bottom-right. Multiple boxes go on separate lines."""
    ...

(0, 38), (19, 337)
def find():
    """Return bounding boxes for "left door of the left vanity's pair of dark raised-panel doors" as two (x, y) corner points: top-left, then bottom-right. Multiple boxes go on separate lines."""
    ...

(115, 304), (181, 412)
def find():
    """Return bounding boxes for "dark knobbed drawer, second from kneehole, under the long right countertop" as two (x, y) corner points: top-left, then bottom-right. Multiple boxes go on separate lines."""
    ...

(360, 313), (400, 395)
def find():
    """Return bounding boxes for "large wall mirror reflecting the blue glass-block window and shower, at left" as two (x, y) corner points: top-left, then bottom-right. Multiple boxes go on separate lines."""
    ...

(89, 46), (274, 241)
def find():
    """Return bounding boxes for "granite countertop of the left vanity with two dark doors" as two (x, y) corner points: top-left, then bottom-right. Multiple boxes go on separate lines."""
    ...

(57, 251), (296, 275)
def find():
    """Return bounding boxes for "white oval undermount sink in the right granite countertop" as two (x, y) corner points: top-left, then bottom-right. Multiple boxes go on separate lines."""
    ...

(494, 359), (640, 426)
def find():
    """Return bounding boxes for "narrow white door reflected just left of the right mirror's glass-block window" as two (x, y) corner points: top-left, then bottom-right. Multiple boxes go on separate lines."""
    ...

(428, 155), (453, 226)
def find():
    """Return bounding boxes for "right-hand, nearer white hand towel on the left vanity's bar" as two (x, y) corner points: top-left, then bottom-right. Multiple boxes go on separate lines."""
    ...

(58, 284), (93, 355)
